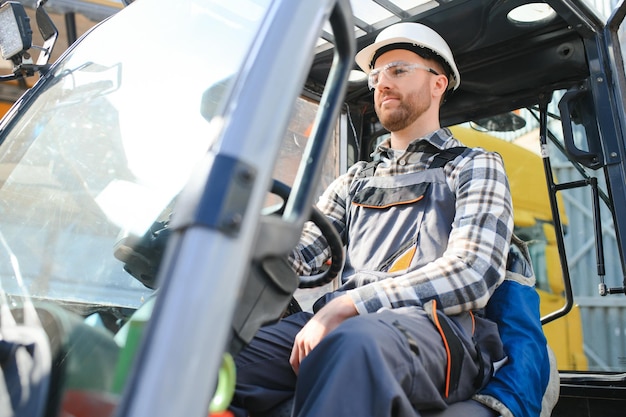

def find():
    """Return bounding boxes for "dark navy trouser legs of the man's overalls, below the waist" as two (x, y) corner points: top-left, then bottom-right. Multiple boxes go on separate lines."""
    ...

(231, 307), (502, 417)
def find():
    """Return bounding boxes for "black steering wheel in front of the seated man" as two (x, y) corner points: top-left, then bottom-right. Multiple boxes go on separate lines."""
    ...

(271, 179), (344, 288)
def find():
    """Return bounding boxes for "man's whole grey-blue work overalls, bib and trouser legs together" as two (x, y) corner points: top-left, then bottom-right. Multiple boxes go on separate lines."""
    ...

(235, 148), (505, 417)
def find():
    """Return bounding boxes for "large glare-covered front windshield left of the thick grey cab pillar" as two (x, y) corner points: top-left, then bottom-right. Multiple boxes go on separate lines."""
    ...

(0, 0), (271, 415)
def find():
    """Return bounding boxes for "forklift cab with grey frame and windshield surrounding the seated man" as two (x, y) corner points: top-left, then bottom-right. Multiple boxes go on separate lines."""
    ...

(0, 0), (626, 417)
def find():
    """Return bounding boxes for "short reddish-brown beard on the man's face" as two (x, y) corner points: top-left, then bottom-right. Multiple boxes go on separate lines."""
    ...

(374, 91), (431, 132)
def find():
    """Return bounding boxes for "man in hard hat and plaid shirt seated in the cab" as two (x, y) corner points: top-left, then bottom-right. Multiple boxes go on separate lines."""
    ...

(233, 23), (544, 417)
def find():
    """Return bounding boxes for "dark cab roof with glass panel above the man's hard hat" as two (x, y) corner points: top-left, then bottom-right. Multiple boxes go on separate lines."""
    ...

(308, 0), (604, 125)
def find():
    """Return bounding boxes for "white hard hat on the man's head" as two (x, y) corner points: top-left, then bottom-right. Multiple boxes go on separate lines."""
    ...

(355, 22), (461, 90)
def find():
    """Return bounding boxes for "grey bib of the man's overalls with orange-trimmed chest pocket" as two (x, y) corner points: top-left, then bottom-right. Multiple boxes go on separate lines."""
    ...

(342, 148), (470, 284)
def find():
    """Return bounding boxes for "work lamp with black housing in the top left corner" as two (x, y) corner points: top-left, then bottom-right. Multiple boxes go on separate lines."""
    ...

(0, 1), (33, 64)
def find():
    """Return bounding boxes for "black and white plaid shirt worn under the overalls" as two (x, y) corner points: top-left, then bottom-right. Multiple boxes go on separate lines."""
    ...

(290, 128), (513, 314)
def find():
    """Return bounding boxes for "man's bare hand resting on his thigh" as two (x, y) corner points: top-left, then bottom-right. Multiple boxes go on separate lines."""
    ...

(289, 294), (358, 374)
